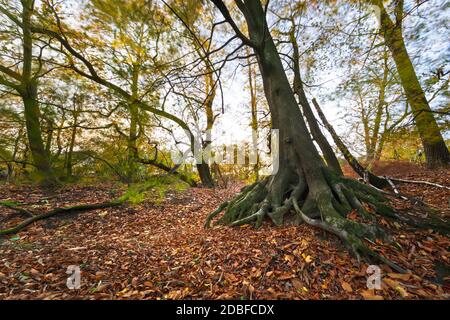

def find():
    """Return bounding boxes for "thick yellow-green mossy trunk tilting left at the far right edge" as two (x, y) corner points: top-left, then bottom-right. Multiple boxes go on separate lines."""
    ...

(370, 0), (450, 168)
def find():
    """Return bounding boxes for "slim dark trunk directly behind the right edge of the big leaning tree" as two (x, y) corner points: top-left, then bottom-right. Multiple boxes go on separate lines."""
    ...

(290, 29), (343, 175)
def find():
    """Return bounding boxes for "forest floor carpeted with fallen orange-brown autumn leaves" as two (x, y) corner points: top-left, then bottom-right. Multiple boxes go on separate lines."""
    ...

(0, 163), (450, 300)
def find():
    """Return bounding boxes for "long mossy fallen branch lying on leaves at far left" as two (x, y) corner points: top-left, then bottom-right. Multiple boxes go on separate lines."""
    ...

(0, 200), (124, 236)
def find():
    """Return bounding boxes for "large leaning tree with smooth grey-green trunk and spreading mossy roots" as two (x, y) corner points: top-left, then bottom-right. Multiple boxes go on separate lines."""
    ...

(206, 0), (448, 270)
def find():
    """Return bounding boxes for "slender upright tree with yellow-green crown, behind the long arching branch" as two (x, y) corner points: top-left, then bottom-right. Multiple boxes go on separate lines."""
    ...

(84, 0), (169, 182)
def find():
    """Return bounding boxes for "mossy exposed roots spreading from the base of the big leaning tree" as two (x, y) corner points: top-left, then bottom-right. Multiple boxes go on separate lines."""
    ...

(205, 169), (449, 272)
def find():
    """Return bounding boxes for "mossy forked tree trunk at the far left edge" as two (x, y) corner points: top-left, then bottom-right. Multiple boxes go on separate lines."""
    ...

(0, 0), (57, 186)
